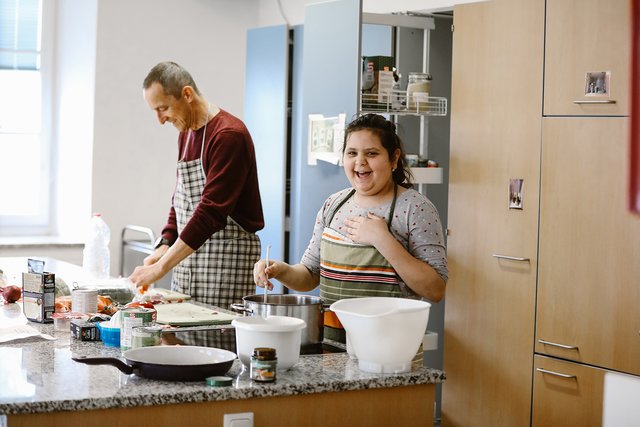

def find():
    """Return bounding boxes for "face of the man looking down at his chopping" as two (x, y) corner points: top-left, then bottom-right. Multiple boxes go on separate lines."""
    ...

(143, 82), (193, 132)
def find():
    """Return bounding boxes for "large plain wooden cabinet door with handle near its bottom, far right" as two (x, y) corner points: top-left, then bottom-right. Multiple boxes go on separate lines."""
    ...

(536, 117), (640, 375)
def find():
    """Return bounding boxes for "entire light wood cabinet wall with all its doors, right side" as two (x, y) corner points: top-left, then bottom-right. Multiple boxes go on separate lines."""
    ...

(442, 0), (640, 426)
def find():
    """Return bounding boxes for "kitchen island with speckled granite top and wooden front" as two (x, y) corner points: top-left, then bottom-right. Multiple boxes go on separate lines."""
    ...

(0, 258), (445, 427)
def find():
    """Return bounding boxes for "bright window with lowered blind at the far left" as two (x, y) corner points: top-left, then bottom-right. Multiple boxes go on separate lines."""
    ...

(0, 0), (51, 236)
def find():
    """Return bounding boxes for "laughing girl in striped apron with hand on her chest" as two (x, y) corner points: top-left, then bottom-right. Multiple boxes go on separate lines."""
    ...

(253, 114), (448, 342)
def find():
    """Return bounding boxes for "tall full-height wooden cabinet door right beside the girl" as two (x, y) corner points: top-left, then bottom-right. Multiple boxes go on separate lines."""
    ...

(442, 0), (544, 427)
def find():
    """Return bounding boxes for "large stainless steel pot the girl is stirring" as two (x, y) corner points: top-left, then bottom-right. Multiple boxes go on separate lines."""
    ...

(231, 294), (324, 347)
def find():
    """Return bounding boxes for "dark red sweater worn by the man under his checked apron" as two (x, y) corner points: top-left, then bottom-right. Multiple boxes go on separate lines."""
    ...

(162, 110), (264, 250)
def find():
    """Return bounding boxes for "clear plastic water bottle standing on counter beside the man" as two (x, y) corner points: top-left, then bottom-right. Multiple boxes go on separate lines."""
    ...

(82, 213), (111, 279)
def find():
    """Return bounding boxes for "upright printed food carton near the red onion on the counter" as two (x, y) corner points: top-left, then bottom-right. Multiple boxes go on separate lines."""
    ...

(22, 272), (56, 323)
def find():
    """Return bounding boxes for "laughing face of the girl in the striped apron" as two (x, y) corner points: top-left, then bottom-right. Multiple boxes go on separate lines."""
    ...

(343, 129), (400, 201)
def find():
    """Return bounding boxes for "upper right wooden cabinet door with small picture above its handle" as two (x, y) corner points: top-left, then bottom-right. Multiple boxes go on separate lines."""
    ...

(544, 0), (631, 116)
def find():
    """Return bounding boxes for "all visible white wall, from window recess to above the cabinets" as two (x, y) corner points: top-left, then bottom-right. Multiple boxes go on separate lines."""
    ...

(2, 0), (477, 274)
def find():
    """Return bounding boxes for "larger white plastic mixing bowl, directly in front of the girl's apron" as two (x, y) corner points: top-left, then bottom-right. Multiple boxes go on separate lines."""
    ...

(330, 297), (431, 373)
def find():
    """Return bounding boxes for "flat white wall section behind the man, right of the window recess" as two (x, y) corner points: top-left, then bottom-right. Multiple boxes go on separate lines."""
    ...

(92, 0), (257, 273)
